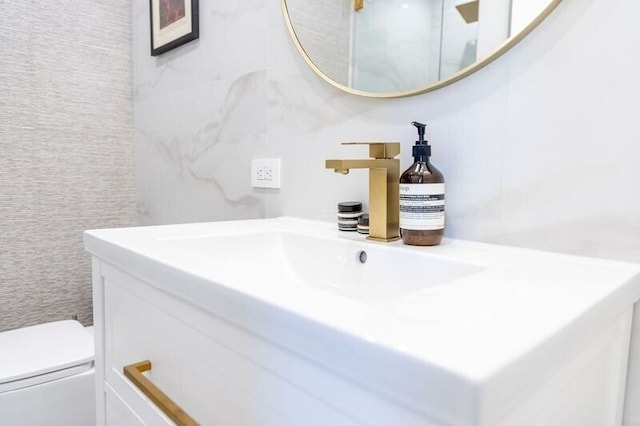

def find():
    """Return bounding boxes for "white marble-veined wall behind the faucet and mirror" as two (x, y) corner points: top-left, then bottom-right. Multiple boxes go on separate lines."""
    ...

(134, 0), (640, 426)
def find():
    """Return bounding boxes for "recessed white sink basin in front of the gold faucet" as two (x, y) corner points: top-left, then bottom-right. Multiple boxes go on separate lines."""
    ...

(160, 230), (482, 301)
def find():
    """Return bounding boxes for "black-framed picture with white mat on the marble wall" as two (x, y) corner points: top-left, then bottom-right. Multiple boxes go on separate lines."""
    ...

(149, 0), (199, 56)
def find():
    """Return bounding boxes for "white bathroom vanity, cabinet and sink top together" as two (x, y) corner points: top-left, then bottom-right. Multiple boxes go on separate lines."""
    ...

(85, 218), (640, 426)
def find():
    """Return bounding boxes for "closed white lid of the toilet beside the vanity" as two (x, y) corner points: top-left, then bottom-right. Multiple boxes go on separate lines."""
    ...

(0, 320), (94, 392)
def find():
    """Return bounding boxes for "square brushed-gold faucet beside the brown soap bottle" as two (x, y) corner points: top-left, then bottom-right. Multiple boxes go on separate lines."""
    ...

(325, 142), (400, 242)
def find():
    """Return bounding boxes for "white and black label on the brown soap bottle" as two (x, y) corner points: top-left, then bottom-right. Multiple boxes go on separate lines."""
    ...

(400, 183), (444, 231)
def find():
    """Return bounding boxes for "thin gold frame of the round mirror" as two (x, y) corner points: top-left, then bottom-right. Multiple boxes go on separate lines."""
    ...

(280, 0), (562, 98)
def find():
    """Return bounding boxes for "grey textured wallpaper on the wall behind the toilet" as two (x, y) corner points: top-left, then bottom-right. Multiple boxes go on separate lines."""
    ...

(0, 0), (135, 330)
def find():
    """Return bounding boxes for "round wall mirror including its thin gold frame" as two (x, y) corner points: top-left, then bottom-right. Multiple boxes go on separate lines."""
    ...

(281, 0), (561, 98)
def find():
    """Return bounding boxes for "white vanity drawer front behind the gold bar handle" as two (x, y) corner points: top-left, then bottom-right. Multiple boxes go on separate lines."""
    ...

(102, 264), (368, 426)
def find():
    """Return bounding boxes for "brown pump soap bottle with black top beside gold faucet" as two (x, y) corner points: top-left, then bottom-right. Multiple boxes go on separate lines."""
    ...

(400, 121), (444, 246)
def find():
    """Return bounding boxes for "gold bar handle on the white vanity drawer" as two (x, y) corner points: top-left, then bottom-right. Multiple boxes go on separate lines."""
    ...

(122, 361), (198, 426)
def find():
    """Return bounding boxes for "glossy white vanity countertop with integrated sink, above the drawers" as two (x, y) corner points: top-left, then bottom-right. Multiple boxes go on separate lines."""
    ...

(84, 217), (640, 424)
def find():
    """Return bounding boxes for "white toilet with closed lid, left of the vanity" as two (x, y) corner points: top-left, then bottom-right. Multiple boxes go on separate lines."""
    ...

(0, 320), (96, 426)
